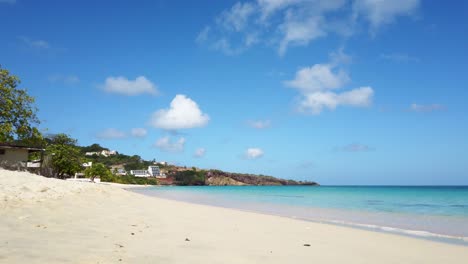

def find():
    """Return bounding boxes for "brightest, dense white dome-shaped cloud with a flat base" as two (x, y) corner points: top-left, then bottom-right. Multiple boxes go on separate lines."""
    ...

(149, 94), (210, 130)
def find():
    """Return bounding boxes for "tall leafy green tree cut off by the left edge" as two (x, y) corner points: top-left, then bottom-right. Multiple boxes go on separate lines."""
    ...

(0, 66), (40, 143)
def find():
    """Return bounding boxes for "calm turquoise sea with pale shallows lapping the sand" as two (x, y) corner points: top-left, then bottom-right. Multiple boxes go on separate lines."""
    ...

(132, 186), (468, 245)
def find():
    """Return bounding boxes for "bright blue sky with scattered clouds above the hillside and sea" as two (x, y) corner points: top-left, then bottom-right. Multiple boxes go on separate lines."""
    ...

(0, 0), (468, 185)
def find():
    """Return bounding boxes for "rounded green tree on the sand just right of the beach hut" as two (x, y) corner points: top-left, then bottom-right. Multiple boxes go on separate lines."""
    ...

(46, 134), (83, 178)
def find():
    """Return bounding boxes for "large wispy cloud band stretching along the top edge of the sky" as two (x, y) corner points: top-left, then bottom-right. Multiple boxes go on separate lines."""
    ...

(196, 0), (420, 55)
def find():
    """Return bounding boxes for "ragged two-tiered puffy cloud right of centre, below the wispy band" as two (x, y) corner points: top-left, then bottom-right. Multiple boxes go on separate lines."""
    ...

(284, 51), (374, 114)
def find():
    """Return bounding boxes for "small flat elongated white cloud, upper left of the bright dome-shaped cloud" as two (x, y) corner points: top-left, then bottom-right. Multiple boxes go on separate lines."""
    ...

(102, 76), (158, 96)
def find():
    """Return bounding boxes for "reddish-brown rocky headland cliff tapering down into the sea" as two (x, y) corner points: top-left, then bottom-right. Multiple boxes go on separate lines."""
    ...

(205, 170), (318, 185)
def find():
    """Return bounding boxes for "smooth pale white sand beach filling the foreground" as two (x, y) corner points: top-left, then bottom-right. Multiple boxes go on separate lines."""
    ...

(0, 169), (468, 264)
